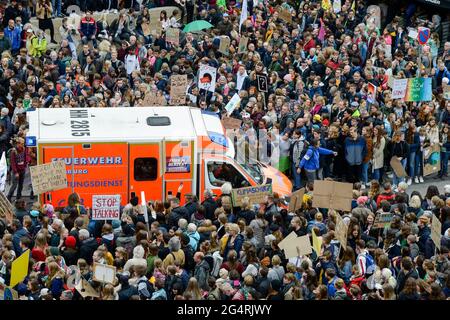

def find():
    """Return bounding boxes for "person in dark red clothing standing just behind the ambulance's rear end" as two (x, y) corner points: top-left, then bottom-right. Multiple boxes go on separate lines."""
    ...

(8, 138), (30, 201)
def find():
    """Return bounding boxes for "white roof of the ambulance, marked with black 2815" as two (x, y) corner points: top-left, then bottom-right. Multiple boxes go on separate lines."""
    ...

(27, 107), (224, 143)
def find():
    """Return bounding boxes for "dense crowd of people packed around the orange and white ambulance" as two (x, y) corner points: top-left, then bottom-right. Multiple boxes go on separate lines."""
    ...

(0, 0), (450, 300)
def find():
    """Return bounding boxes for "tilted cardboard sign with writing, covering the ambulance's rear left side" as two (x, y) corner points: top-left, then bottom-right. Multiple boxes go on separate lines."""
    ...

(30, 160), (67, 194)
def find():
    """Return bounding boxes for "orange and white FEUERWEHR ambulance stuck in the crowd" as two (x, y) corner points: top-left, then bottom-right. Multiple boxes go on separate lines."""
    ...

(26, 107), (292, 207)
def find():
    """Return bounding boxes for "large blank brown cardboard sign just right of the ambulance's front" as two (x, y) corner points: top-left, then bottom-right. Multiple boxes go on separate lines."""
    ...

(313, 180), (353, 211)
